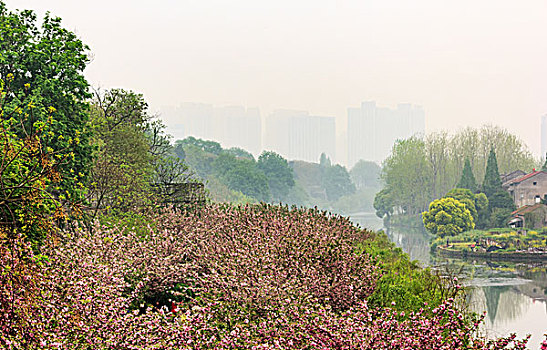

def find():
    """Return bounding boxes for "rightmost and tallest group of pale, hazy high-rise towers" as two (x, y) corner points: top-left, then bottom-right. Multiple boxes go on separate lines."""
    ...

(347, 101), (425, 168)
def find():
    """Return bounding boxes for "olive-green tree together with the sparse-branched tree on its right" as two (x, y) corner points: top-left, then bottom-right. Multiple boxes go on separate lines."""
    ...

(85, 89), (195, 217)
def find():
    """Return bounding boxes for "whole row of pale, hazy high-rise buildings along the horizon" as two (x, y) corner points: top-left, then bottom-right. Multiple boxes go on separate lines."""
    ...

(162, 101), (425, 168)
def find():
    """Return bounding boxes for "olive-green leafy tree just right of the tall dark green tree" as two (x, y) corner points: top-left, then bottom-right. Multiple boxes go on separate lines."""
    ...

(89, 89), (154, 213)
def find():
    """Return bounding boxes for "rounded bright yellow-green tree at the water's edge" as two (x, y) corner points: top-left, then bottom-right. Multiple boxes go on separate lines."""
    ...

(422, 198), (475, 237)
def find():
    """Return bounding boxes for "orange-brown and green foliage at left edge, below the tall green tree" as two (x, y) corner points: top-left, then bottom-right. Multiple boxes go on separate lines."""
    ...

(0, 80), (69, 245)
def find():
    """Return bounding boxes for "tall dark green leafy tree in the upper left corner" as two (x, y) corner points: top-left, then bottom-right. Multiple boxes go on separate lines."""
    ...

(0, 1), (92, 197)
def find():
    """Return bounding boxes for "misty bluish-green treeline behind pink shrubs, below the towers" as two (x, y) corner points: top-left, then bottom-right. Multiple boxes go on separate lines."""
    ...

(175, 137), (380, 214)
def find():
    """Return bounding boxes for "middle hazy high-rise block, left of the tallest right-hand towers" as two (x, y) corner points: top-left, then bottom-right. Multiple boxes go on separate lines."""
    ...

(264, 110), (336, 163)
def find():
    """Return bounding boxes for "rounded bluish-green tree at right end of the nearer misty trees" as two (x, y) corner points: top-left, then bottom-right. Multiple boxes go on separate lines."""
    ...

(257, 151), (294, 202)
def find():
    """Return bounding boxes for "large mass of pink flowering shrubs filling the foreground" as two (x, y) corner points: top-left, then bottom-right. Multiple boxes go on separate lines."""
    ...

(0, 205), (526, 349)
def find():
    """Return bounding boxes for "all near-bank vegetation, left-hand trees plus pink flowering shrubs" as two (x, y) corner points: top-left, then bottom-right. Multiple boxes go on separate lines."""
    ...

(0, 1), (547, 349)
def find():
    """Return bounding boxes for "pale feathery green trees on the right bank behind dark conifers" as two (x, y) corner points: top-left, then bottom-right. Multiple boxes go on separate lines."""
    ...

(375, 126), (540, 216)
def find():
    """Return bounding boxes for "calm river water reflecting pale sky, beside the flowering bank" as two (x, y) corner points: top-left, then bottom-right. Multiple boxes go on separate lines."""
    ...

(350, 213), (547, 349)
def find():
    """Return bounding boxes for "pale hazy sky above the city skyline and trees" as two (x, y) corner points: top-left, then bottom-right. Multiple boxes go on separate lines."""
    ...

(5, 0), (547, 155)
